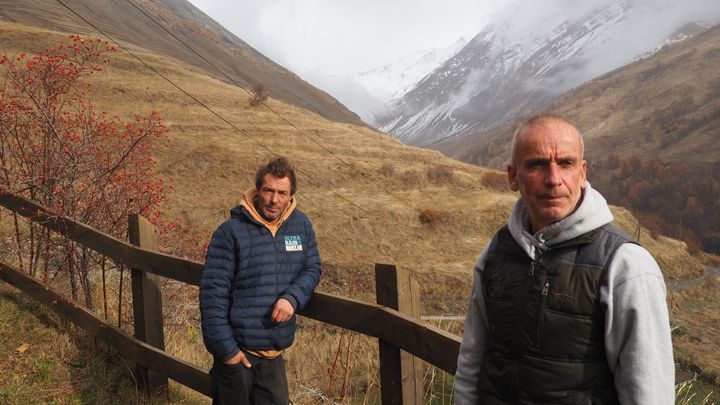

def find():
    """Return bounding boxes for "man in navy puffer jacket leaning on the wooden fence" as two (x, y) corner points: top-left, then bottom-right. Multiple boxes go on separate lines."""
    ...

(200, 157), (321, 405)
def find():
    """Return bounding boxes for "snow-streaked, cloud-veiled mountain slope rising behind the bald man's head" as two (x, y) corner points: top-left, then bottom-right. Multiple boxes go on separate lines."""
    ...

(376, 0), (720, 146)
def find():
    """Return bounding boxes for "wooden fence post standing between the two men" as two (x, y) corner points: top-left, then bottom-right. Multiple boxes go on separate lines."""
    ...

(375, 264), (423, 405)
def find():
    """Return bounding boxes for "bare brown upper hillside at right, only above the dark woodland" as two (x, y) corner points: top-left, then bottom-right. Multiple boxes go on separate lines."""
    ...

(438, 22), (720, 168)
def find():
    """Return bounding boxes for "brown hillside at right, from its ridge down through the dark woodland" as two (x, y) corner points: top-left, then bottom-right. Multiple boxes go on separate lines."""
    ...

(438, 22), (720, 253)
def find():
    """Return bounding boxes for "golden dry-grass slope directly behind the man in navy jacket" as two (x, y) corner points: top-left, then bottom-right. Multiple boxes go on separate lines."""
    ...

(0, 19), (514, 307)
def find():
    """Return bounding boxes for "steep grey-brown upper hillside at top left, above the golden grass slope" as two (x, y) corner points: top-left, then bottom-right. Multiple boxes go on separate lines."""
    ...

(0, 0), (361, 124)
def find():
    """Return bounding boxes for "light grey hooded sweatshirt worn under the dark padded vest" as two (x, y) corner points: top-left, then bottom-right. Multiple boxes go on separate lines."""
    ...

(455, 183), (675, 405)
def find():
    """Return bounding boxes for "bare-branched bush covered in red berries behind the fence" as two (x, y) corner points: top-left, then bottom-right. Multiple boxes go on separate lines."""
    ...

(0, 36), (181, 308)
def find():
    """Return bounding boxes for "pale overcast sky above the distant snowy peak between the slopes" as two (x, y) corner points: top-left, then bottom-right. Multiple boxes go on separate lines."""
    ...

(190, 0), (500, 77)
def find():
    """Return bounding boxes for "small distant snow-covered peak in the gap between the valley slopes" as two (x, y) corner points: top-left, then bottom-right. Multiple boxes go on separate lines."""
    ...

(352, 37), (468, 104)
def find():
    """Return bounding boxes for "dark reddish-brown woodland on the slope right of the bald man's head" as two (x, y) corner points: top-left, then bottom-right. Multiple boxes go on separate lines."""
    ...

(588, 154), (720, 254)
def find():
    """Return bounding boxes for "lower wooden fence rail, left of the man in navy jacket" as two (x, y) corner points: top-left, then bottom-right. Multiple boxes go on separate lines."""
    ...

(0, 262), (210, 396)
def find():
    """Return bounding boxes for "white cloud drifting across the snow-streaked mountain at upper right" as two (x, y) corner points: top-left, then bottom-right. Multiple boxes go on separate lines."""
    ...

(455, 0), (720, 106)
